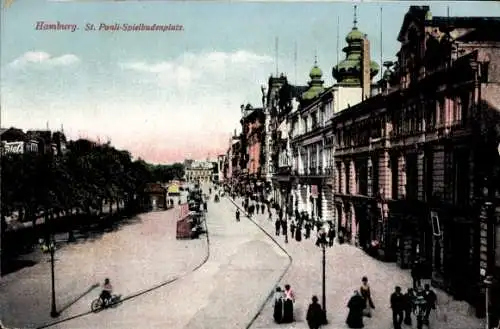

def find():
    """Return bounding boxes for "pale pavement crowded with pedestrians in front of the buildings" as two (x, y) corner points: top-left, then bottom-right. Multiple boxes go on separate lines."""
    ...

(229, 199), (484, 329)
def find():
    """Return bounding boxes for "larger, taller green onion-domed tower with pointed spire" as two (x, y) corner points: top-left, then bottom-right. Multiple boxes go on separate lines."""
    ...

(332, 6), (379, 86)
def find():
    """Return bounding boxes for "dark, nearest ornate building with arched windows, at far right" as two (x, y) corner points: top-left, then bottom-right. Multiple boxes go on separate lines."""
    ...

(332, 6), (500, 309)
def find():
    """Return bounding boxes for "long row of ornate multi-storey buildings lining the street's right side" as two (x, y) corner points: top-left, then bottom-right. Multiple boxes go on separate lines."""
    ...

(222, 6), (500, 313)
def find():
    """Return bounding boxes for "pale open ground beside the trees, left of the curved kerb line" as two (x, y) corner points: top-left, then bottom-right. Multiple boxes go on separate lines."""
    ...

(0, 210), (207, 328)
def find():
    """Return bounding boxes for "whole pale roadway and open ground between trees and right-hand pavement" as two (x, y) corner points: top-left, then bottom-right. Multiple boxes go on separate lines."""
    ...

(0, 190), (289, 329)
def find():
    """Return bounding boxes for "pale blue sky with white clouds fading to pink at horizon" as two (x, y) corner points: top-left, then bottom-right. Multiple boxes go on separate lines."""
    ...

(0, 0), (500, 163)
